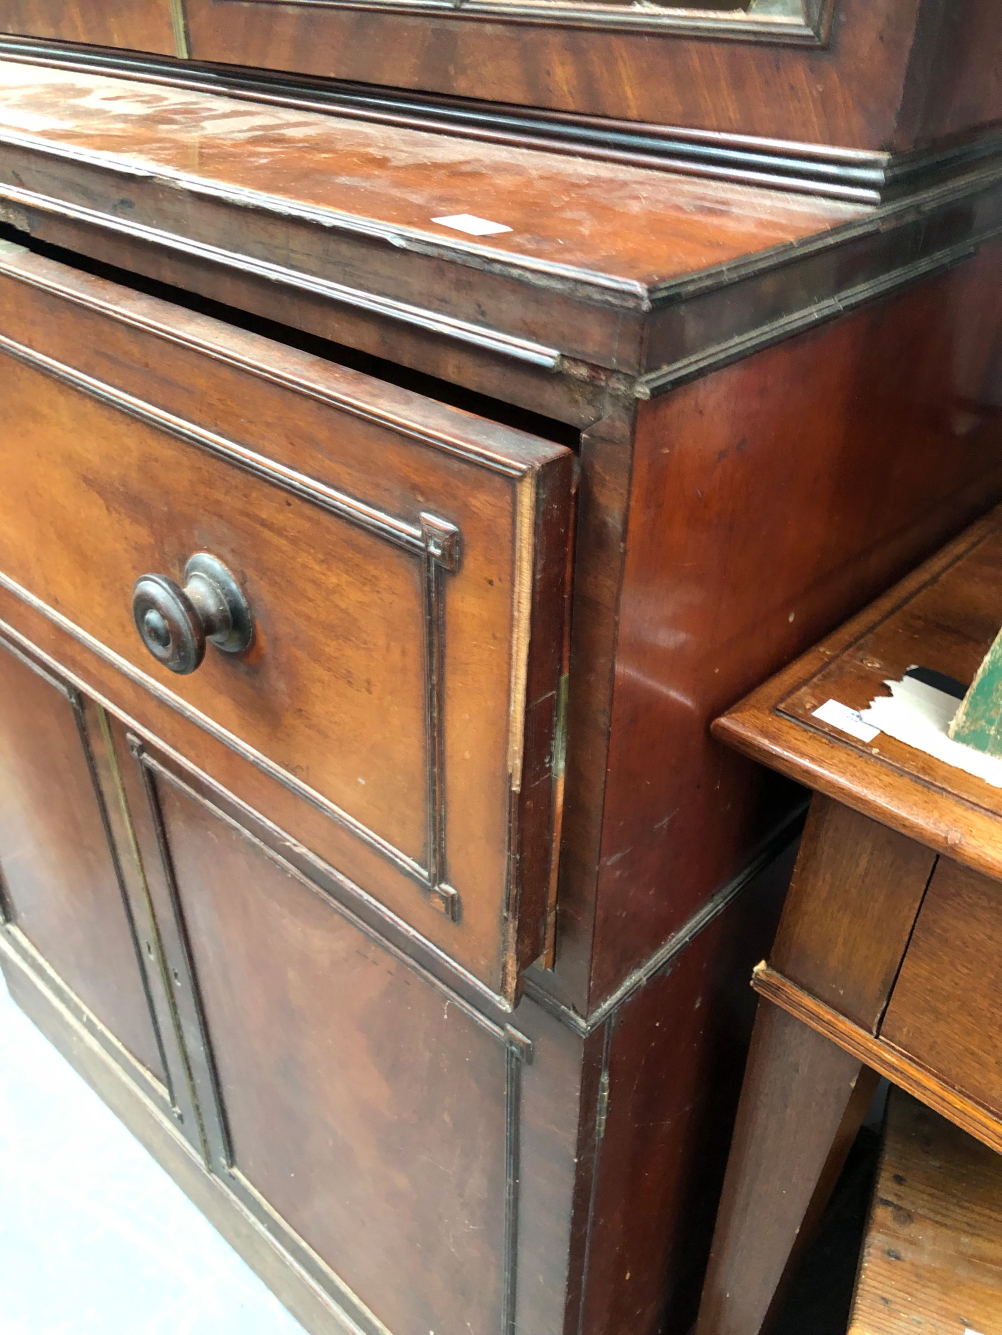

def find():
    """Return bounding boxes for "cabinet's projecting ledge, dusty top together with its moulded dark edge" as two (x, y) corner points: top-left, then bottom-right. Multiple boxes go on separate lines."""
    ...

(0, 60), (1002, 426)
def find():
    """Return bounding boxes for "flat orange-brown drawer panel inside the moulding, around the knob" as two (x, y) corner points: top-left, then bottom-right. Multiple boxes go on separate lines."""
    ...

(0, 344), (427, 864)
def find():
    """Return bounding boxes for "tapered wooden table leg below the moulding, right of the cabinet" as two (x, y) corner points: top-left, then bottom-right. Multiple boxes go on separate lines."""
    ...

(696, 1001), (878, 1335)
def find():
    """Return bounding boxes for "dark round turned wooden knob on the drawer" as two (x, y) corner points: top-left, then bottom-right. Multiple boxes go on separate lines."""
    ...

(132, 551), (254, 676)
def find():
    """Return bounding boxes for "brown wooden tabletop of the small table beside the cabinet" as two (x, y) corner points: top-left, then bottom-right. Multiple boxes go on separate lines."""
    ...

(714, 507), (1002, 880)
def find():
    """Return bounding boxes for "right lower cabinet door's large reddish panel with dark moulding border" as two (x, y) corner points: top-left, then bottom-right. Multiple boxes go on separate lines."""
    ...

(116, 729), (532, 1335)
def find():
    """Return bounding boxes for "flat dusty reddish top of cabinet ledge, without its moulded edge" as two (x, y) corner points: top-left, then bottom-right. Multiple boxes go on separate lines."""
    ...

(0, 60), (871, 294)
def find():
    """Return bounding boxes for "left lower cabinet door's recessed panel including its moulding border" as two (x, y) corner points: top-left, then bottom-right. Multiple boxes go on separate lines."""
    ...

(0, 637), (195, 1136)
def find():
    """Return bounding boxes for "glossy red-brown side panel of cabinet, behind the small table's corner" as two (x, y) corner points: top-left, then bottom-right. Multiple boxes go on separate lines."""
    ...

(592, 243), (1002, 997)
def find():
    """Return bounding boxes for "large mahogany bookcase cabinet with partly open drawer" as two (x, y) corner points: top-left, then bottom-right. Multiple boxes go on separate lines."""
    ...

(0, 0), (1002, 1335)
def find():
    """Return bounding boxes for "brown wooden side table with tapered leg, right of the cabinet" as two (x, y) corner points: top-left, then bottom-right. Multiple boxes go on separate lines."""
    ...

(696, 510), (1002, 1335)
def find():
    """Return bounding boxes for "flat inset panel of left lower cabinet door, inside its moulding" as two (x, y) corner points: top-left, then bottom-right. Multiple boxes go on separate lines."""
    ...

(0, 641), (167, 1081)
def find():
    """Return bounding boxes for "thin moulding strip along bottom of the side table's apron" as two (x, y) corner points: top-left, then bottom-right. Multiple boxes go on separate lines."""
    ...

(751, 961), (1002, 1153)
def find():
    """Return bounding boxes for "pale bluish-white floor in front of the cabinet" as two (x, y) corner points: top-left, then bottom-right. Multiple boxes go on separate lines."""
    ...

(0, 977), (303, 1335)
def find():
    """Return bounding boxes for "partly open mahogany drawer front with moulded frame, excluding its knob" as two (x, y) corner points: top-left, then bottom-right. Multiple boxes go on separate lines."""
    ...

(0, 247), (572, 996)
